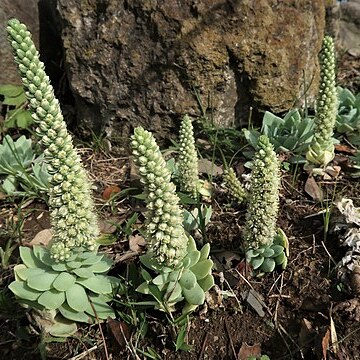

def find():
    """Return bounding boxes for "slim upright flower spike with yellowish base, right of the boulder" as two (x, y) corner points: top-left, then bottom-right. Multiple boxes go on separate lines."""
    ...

(306, 36), (337, 167)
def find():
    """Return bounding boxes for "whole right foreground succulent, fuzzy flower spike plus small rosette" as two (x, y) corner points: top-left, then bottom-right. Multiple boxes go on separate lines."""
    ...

(244, 135), (289, 272)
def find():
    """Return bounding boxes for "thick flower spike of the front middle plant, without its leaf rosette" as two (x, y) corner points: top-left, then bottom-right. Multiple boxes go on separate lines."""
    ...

(131, 127), (188, 267)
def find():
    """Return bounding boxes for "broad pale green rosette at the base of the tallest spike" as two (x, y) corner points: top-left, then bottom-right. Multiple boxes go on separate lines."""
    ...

(9, 246), (120, 323)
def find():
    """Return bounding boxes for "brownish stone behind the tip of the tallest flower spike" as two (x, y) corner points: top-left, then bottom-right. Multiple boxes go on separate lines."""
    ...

(0, 0), (39, 85)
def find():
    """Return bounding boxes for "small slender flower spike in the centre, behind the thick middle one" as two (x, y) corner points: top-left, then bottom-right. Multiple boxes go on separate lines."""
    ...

(178, 115), (199, 198)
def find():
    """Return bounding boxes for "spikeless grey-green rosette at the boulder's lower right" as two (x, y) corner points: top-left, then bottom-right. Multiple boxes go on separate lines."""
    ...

(243, 109), (314, 162)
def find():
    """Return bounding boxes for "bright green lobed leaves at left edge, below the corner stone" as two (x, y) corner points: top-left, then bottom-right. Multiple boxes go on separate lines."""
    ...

(0, 85), (33, 129)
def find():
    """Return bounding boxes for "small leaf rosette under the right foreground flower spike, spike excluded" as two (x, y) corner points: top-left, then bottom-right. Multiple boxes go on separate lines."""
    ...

(245, 229), (289, 272)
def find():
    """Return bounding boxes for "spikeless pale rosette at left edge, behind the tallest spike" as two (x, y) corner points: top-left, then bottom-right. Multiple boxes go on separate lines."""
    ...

(0, 135), (49, 199)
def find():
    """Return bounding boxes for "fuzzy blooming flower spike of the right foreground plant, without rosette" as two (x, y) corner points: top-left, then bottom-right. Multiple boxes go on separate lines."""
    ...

(244, 135), (280, 249)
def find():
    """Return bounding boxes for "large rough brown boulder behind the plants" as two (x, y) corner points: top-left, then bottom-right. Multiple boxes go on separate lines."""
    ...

(57, 0), (325, 146)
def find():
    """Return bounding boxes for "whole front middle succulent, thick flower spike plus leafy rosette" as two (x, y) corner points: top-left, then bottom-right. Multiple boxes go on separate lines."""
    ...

(131, 127), (214, 313)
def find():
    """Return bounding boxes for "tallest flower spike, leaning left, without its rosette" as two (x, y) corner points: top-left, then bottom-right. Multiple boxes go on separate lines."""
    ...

(7, 19), (99, 260)
